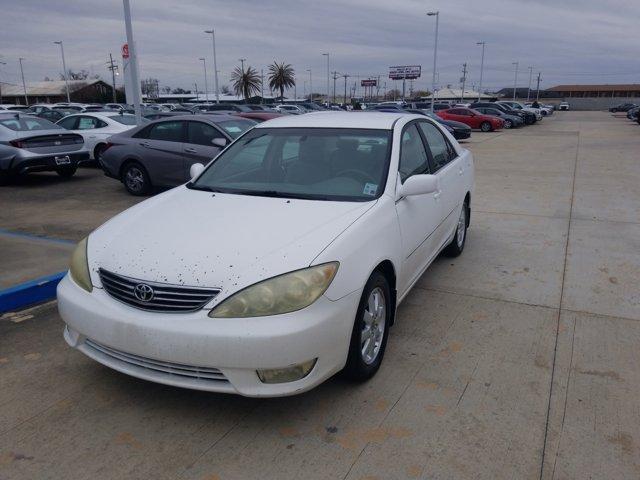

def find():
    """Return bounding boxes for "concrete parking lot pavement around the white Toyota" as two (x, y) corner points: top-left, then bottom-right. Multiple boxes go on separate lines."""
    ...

(0, 112), (640, 480)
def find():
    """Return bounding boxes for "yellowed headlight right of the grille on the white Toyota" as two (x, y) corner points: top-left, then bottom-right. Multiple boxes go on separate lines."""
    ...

(209, 262), (339, 318)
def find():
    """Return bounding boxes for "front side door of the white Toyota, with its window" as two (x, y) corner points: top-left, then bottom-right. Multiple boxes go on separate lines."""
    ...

(396, 122), (443, 289)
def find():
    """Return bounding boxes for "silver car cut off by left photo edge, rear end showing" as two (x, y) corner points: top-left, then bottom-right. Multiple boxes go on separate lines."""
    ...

(0, 112), (89, 184)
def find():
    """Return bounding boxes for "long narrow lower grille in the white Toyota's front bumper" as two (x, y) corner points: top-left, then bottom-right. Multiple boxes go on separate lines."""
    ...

(85, 338), (228, 382)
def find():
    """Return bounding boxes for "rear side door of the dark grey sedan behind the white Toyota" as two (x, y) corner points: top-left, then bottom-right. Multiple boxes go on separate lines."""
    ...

(138, 120), (186, 186)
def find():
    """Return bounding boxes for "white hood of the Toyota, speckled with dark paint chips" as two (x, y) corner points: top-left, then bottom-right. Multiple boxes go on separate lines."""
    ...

(88, 186), (375, 298)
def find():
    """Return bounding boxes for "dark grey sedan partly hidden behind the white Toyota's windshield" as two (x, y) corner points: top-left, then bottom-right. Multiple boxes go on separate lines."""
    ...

(100, 115), (256, 195)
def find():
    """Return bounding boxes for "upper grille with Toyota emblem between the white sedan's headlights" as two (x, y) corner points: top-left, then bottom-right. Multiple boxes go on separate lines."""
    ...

(99, 268), (220, 313)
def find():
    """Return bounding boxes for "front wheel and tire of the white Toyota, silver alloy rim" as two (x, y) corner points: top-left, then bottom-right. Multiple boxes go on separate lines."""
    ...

(344, 271), (392, 382)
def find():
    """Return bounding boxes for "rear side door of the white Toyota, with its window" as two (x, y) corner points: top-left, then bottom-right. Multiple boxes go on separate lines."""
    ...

(418, 121), (467, 250)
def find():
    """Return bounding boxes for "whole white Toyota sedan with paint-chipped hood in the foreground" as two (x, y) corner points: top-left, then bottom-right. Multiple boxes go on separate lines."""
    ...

(58, 112), (474, 396)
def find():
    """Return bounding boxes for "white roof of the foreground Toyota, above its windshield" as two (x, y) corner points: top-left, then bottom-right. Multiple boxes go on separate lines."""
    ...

(254, 111), (404, 130)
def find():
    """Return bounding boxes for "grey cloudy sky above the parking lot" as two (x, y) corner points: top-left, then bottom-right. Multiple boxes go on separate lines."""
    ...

(0, 0), (640, 93)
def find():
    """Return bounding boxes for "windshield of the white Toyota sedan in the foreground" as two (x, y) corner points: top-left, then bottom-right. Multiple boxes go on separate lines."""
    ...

(190, 128), (391, 201)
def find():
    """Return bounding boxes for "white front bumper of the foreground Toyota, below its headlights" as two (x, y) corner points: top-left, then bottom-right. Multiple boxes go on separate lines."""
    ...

(58, 275), (362, 397)
